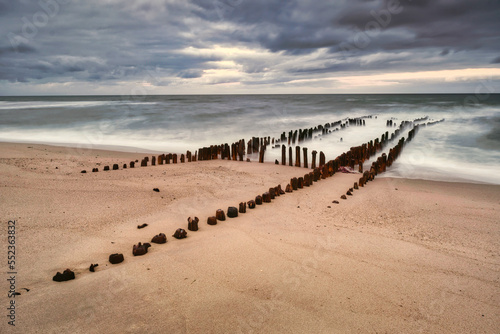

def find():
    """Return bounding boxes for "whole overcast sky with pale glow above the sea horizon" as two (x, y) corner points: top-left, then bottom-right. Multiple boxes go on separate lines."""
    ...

(0, 0), (500, 96)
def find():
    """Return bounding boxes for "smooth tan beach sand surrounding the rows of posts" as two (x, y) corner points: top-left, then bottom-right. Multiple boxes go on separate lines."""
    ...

(0, 143), (500, 333)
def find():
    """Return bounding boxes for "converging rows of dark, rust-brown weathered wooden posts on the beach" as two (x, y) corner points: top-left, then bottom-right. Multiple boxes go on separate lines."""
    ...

(67, 118), (444, 281)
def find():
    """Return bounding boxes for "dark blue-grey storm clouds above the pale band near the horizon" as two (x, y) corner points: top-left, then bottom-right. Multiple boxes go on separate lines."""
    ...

(0, 0), (500, 93)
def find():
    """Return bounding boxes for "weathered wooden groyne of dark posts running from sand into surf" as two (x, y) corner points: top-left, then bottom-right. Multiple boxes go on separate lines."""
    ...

(67, 114), (444, 282)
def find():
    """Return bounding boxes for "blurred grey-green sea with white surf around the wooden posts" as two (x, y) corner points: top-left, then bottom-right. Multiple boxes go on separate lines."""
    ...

(0, 93), (500, 184)
